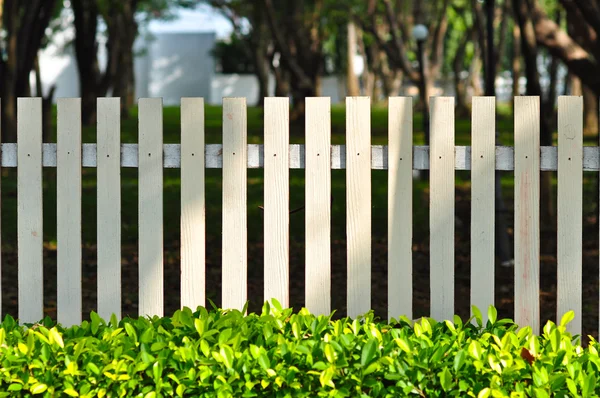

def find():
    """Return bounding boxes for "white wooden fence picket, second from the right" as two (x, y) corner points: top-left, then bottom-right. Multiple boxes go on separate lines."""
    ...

(514, 96), (540, 334)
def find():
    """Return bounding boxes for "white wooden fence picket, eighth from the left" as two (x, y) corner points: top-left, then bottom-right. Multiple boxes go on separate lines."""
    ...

(305, 97), (331, 315)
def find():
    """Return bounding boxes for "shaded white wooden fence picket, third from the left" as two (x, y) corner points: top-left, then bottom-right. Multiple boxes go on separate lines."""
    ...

(96, 98), (121, 319)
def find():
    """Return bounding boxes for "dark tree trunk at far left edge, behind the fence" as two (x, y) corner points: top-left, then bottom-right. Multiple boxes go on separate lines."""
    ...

(0, 0), (59, 142)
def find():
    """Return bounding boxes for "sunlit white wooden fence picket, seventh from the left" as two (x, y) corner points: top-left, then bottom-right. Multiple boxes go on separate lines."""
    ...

(264, 97), (290, 308)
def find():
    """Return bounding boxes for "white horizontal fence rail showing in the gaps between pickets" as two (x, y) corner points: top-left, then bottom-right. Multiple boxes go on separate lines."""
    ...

(0, 143), (600, 171)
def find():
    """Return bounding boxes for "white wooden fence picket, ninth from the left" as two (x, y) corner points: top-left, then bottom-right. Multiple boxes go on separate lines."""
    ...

(346, 97), (371, 317)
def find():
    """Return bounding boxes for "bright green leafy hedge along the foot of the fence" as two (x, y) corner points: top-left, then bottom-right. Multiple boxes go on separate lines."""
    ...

(0, 301), (600, 398)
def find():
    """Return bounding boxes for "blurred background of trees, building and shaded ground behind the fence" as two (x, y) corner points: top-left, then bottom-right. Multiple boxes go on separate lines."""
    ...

(0, 0), (600, 335)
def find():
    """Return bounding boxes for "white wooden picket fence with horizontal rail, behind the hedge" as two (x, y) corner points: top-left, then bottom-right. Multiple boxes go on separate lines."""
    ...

(1, 97), (588, 333)
